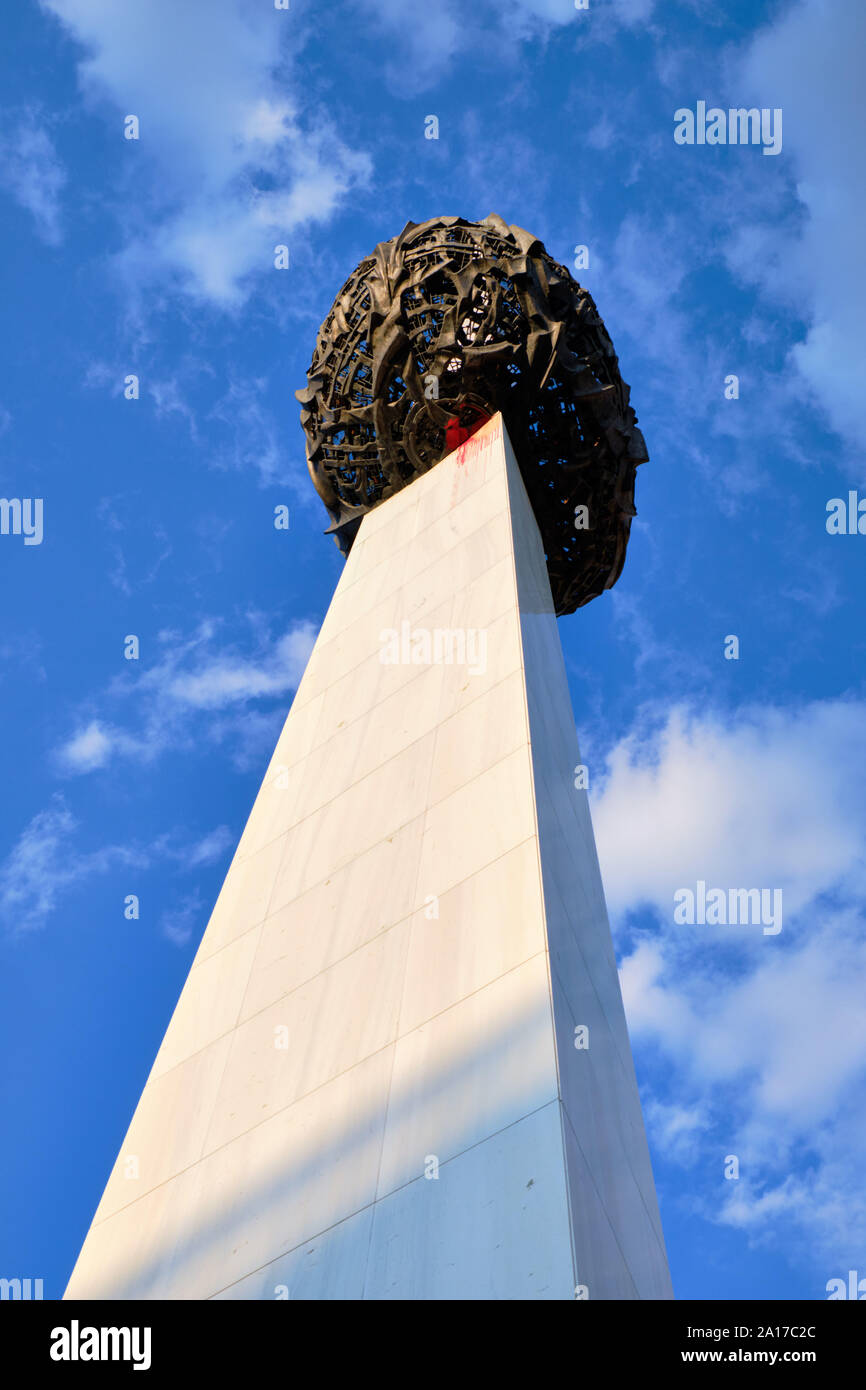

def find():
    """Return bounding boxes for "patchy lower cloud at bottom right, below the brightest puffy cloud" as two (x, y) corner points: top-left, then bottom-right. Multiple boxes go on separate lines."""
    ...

(621, 912), (866, 1267)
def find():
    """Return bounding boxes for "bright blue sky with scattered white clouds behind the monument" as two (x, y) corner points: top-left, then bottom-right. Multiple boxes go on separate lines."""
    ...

(0, 0), (866, 1298)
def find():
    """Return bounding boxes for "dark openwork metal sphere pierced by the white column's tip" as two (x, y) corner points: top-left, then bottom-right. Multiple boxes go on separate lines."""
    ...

(296, 215), (646, 614)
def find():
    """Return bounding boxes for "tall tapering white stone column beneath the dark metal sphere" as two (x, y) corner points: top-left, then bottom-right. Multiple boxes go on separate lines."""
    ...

(67, 416), (671, 1300)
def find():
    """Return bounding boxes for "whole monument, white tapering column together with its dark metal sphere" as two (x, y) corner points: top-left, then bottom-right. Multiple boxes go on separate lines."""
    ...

(67, 217), (671, 1301)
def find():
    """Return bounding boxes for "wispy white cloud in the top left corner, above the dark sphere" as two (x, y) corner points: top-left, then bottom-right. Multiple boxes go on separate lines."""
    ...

(42, 0), (371, 309)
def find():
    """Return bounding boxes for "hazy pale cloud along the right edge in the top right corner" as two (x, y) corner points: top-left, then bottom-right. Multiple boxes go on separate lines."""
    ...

(731, 0), (866, 446)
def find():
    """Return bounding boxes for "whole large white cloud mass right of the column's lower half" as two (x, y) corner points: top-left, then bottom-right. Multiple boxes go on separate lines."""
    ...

(594, 699), (866, 1267)
